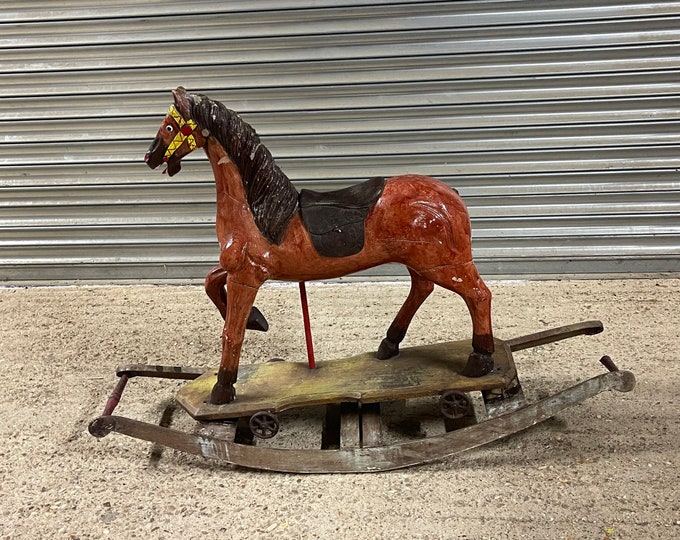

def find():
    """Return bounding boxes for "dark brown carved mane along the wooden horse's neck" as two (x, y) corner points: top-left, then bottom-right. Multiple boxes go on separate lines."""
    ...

(189, 94), (299, 244)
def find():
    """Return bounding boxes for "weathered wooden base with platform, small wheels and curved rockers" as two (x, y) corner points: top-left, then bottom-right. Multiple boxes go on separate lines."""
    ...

(88, 321), (635, 473)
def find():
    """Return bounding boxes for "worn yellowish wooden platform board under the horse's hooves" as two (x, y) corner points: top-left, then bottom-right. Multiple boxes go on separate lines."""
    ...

(176, 340), (517, 420)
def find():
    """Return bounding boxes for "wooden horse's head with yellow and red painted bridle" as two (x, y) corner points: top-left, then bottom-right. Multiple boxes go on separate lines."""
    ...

(144, 86), (208, 176)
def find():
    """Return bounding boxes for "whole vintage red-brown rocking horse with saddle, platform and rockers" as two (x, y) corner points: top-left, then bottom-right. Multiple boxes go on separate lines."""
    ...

(89, 87), (635, 473)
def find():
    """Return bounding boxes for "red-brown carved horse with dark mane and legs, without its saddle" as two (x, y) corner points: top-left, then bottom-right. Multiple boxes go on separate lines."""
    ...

(145, 87), (493, 404)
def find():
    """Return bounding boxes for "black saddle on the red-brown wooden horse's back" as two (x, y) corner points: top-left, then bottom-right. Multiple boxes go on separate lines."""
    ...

(300, 177), (386, 257)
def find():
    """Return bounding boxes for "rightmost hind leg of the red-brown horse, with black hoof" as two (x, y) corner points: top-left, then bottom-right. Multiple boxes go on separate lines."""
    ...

(425, 262), (494, 377)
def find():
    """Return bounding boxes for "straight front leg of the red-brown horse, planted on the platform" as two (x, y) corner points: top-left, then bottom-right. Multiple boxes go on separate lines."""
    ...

(210, 276), (259, 405)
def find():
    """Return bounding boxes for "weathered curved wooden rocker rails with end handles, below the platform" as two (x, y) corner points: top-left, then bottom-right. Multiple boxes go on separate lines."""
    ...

(89, 321), (635, 473)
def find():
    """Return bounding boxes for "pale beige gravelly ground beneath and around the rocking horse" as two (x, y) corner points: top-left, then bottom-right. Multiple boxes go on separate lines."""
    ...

(0, 279), (680, 540)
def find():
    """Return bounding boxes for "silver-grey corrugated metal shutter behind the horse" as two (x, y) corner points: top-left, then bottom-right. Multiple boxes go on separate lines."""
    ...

(0, 0), (680, 282)
